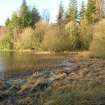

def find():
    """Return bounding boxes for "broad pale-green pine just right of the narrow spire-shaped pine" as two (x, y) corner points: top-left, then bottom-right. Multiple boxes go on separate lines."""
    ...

(66, 0), (78, 21)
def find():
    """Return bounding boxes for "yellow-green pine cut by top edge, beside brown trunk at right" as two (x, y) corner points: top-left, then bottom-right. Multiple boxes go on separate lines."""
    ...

(86, 0), (96, 24)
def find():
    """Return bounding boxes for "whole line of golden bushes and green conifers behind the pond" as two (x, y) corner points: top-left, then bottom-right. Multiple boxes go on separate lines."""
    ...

(0, 0), (105, 57)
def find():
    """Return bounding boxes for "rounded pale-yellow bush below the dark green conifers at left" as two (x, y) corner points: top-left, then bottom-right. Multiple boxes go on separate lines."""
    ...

(15, 27), (35, 49)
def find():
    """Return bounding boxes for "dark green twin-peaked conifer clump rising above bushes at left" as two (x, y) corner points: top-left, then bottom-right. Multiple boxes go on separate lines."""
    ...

(19, 0), (40, 28)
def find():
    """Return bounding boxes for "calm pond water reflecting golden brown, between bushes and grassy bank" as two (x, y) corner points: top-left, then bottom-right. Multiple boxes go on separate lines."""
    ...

(0, 52), (69, 78)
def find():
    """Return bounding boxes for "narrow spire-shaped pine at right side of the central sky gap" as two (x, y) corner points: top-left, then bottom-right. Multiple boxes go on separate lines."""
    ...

(57, 2), (64, 25)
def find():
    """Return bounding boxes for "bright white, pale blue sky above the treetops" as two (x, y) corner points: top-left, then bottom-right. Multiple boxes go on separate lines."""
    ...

(0, 0), (85, 25)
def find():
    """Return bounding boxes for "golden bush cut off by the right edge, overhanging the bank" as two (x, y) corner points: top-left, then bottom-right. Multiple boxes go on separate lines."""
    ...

(90, 20), (105, 58)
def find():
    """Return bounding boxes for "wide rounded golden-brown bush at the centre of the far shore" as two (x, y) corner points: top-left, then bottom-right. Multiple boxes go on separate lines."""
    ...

(42, 26), (70, 52)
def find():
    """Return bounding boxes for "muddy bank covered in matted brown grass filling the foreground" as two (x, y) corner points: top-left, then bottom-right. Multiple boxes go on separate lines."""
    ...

(0, 60), (105, 105)
